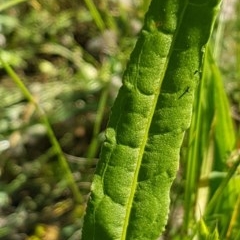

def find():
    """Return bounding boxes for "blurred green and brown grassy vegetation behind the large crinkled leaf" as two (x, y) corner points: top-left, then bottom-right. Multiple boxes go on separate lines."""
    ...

(0, 0), (240, 240)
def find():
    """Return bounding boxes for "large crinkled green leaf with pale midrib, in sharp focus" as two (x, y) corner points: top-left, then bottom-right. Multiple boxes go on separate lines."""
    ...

(83, 0), (220, 240)
